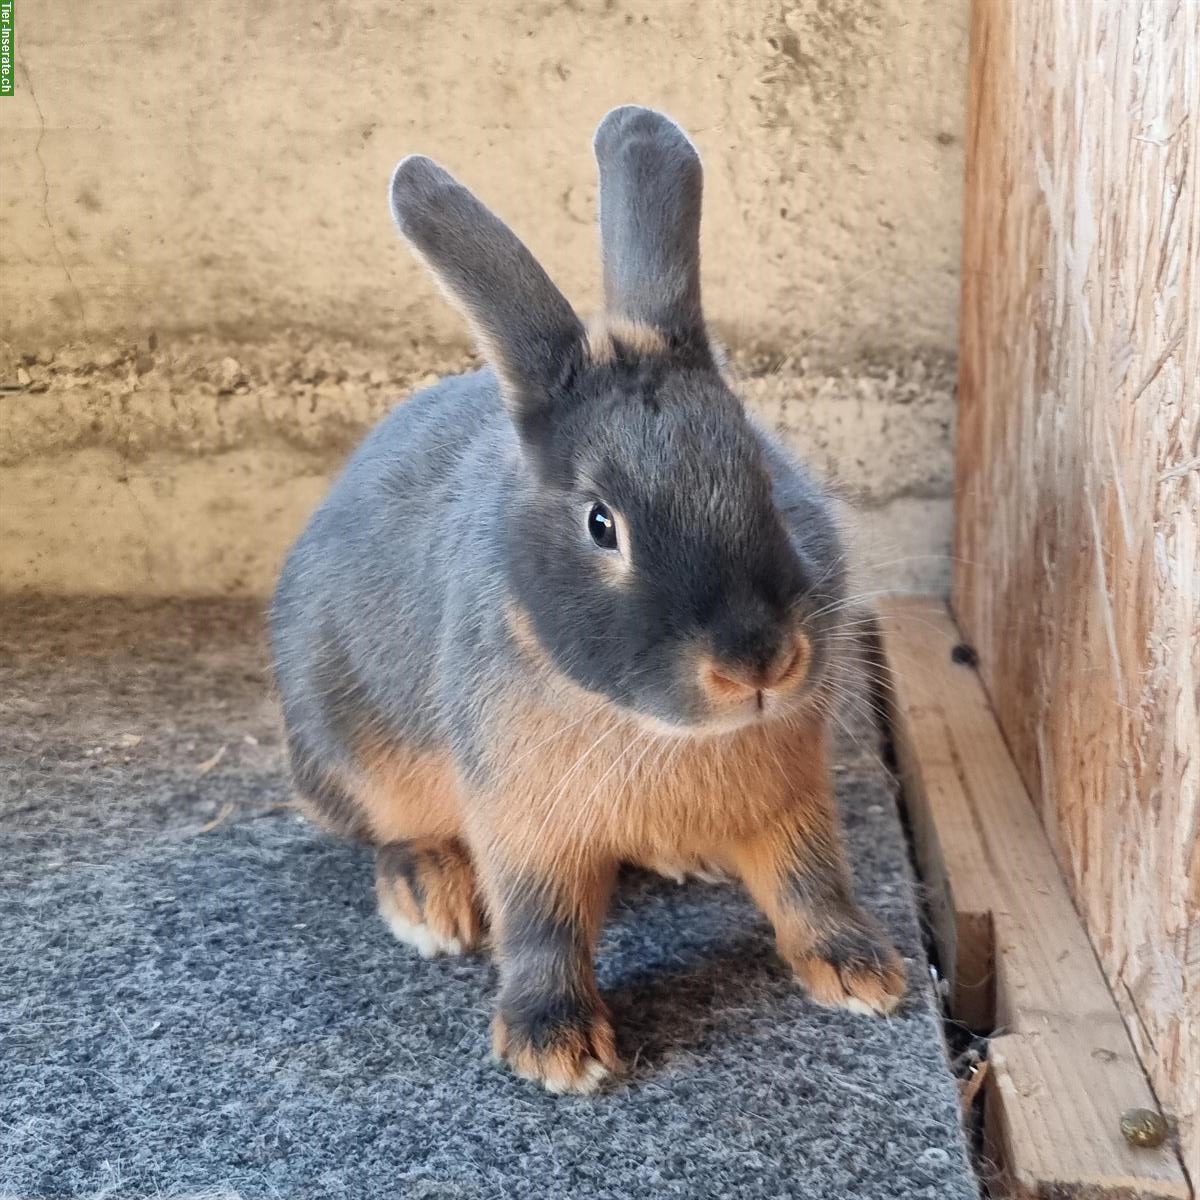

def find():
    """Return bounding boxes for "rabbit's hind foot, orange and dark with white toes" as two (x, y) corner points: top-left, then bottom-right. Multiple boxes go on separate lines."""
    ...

(376, 838), (484, 959)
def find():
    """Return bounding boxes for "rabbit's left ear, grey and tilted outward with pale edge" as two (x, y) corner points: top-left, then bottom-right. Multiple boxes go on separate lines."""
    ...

(391, 155), (584, 418)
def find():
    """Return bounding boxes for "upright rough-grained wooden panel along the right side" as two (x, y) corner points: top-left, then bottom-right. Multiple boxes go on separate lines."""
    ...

(954, 0), (1200, 1184)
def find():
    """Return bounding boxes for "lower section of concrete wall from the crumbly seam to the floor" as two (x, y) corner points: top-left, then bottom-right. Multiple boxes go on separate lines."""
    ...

(0, 335), (954, 595)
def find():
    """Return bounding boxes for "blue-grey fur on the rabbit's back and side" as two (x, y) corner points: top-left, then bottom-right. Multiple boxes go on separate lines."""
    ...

(270, 371), (511, 824)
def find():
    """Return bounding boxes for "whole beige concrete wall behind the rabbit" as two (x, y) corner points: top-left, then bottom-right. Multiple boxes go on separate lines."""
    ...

(0, 0), (966, 592)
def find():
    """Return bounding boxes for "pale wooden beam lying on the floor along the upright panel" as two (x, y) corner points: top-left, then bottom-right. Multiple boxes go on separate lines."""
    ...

(881, 600), (1190, 1200)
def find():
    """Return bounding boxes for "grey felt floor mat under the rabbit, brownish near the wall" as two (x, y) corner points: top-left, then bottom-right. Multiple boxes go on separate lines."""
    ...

(0, 600), (976, 1200)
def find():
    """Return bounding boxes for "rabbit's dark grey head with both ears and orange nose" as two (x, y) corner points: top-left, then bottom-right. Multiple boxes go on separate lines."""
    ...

(391, 107), (844, 734)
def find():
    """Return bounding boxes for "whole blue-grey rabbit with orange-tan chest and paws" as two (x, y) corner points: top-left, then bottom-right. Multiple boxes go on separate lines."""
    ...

(270, 107), (905, 1092)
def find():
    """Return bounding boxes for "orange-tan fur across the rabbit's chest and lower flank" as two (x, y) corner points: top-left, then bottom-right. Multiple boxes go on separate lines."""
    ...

(355, 610), (829, 874)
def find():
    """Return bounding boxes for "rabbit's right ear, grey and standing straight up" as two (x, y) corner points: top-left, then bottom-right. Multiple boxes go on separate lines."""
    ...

(593, 106), (712, 365)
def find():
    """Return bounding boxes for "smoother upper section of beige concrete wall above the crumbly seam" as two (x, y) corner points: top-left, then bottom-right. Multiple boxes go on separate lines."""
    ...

(0, 0), (967, 356)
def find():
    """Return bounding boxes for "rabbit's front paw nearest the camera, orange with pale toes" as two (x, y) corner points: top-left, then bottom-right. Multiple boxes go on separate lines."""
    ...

(492, 1010), (620, 1093)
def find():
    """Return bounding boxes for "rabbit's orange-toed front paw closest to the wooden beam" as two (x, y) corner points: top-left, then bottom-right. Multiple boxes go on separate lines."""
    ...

(791, 910), (906, 1016)
